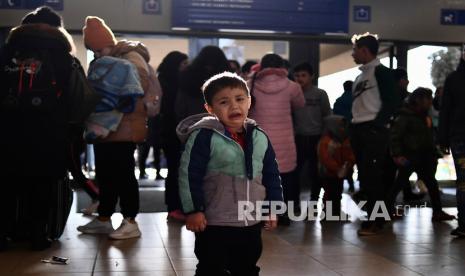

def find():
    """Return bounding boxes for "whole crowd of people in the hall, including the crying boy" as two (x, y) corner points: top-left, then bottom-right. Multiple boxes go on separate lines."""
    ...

(0, 4), (465, 275)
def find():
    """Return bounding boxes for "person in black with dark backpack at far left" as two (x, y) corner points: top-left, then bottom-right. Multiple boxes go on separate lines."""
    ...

(0, 7), (89, 250)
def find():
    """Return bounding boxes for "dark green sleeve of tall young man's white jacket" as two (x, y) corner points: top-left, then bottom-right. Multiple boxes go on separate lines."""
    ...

(375, 65), (401, 126)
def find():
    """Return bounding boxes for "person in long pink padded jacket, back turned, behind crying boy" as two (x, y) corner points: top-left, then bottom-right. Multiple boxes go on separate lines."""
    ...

(248, 54), (305, 225)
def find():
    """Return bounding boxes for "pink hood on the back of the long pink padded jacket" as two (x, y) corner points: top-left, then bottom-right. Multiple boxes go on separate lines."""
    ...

(255, 68), (290, 94)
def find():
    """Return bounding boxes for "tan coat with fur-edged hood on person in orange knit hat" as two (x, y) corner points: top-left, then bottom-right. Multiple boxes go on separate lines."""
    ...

(101, 40), (161, 143)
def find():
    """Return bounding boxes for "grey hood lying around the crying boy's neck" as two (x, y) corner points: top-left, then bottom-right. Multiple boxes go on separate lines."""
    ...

(176, 113), (257, 143)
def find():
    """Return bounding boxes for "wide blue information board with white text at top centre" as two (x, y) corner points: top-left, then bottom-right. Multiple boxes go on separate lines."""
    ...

(171, 0), (349, 34)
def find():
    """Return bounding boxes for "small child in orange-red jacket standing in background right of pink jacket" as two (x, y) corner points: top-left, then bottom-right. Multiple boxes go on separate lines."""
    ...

(318, 115), (355, 220)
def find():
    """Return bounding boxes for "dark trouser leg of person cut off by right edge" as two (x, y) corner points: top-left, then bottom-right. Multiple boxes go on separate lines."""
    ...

(451, 141), (465, 231)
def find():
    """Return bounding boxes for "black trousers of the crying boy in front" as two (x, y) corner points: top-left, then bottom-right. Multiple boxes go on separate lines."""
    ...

(194, 223), (262, 276)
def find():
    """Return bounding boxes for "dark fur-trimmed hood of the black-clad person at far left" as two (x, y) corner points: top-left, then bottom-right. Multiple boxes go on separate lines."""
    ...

(6, 24), (75, 53)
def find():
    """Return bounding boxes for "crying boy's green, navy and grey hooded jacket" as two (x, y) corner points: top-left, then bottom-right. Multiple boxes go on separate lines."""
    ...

(177, 114), (283, 227)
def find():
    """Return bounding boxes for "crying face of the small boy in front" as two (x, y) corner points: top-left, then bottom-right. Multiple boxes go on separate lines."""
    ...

(205, 88), (251, 132)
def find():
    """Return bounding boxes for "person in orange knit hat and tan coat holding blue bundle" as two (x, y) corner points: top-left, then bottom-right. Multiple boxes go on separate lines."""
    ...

(77, 16), (161, 239)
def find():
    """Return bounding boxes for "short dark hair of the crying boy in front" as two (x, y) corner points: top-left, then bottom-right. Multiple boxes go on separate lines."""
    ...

(202, 72), (250, 105)
